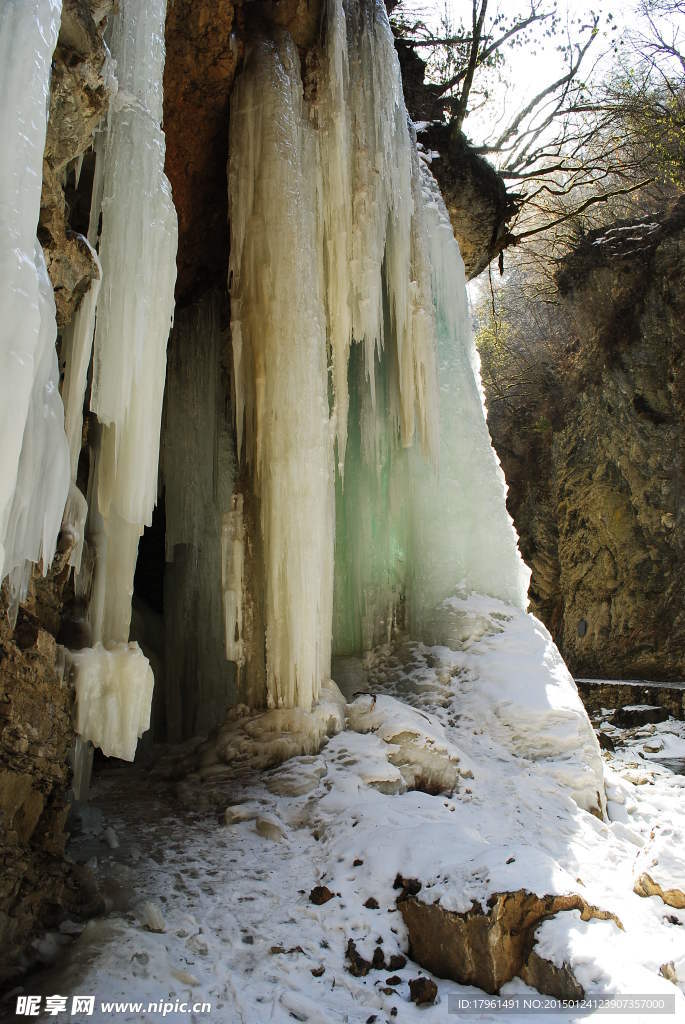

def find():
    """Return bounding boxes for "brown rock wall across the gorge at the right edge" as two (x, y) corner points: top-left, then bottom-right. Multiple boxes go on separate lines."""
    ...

(490, 201), (685, 679)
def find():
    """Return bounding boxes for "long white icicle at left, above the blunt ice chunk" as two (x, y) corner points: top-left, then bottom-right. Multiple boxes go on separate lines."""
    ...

(89, 0), (177, 644)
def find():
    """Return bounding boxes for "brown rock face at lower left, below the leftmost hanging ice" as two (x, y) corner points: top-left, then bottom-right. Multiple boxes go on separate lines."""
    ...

(0, 552), (73, 982)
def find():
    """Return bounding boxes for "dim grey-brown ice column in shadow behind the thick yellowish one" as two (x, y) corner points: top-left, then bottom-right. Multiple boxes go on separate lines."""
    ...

(161, 293), (239, 739)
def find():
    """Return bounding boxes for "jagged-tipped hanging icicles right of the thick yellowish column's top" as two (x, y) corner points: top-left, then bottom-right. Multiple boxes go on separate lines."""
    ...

(313, 0), (438, 473)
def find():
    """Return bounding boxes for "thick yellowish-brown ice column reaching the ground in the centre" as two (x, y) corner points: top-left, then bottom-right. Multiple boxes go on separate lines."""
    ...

(229, 36), (334, 709)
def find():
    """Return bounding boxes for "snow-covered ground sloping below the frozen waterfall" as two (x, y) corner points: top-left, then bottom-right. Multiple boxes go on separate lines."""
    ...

(9, 599), (685, 1024)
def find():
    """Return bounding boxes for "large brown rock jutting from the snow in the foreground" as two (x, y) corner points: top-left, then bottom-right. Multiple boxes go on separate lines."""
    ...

(397, 889), (620, 994)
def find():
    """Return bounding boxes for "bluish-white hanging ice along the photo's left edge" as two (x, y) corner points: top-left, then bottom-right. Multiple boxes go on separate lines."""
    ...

(0, 0), (69, 603)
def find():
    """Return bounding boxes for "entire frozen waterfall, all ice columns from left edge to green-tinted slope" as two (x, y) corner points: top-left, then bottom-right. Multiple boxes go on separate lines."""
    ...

(0, 0), (527, 757)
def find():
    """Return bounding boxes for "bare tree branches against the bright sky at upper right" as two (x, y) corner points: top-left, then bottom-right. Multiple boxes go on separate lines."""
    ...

(399, 0), (685, 260)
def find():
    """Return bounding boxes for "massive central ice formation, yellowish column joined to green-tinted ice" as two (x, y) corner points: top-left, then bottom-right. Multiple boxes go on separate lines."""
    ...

(224, 0), (528, 708)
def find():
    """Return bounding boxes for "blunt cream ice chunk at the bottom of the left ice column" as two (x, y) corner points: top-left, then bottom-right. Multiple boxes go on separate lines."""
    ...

(70, 643), (155, 761)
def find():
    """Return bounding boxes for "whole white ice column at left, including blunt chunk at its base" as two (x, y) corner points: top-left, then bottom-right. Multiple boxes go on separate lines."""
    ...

(65, 0), (177, 760)
